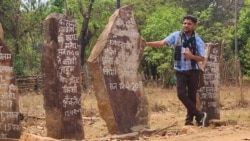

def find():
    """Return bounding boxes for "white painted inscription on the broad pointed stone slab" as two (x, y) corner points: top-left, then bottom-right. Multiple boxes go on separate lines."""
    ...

(101, 14), (142, 91)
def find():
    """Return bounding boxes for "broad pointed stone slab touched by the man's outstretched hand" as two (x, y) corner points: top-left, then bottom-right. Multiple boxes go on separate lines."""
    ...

(88, 5), (148, 134)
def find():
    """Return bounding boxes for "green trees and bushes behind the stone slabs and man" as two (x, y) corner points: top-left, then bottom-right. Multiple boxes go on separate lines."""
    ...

(0, 0), (250, 85)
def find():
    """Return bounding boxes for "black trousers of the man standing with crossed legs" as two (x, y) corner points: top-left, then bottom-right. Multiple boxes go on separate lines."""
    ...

(176, 70), (200, 122)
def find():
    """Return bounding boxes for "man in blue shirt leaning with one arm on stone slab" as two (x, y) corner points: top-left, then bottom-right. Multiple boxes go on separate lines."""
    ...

(144, 15), (207, 127)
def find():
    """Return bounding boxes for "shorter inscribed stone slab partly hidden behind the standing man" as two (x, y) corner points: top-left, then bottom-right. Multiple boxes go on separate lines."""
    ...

(198, 43), (220, 125)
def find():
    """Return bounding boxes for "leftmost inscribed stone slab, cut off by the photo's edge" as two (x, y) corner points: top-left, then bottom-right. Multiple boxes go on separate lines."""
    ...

(0, 27), (21, 140)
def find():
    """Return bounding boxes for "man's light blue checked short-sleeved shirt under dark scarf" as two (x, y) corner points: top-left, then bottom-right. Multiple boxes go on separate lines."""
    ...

(165, 31), (205, 71)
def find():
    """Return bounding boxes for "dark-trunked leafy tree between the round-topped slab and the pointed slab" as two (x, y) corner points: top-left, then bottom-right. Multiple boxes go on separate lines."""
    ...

(66, 0), (116, 66)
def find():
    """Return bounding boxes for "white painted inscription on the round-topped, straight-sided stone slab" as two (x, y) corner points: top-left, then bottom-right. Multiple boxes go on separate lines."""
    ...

(57, 19), (81, 117)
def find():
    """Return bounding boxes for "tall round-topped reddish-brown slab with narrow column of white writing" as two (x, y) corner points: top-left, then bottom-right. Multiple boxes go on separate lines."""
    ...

(42, 13), (84, 140)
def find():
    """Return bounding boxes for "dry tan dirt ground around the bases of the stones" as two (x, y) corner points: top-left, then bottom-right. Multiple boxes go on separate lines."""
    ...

(19, 84), (250, 141)
